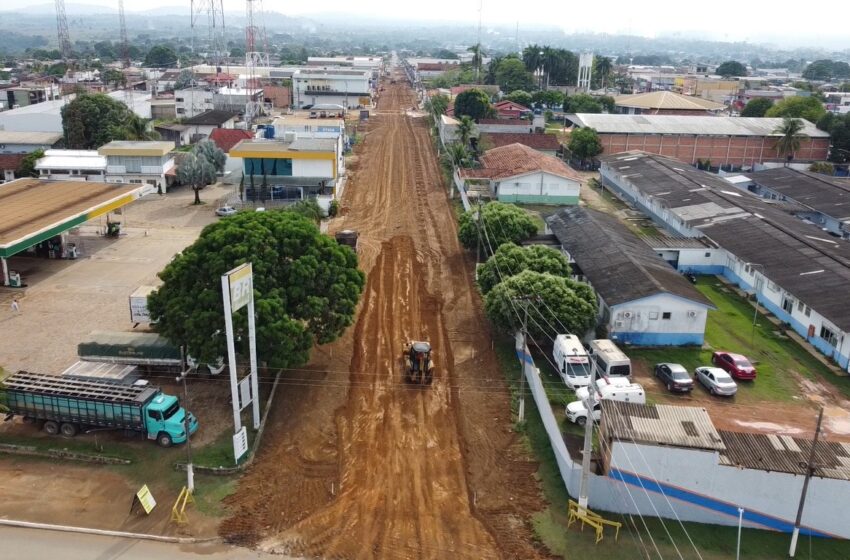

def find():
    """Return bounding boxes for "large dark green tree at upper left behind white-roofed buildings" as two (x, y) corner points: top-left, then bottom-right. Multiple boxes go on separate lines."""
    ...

(62, 93), (137, 150)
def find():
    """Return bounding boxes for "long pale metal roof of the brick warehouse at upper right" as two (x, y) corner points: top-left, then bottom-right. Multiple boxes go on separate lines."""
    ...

(567, 113), (829, 138)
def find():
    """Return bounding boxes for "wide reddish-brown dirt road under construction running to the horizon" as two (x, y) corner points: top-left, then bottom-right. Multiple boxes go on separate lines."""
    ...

(221, 75), (542, 559)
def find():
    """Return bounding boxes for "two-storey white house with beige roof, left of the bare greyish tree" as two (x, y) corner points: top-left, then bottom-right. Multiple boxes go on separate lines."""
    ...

(97, 140), (175, 192)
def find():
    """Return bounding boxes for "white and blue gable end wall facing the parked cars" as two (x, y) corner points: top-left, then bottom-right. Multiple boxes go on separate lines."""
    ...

(607, 294), (708, 346)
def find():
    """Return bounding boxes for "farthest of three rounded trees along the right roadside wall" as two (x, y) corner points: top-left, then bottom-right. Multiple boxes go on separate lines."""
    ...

(458, 202), (537, 253)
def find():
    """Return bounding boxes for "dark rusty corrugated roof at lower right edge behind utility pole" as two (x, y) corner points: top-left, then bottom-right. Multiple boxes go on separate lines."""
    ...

(719, 431), (850, 480)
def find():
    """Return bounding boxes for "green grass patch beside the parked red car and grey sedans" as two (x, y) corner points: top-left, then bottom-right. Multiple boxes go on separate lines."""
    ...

(628, 277), (850, 403)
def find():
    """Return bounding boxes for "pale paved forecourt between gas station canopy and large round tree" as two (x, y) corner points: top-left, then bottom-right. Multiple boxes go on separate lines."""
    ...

(0, 186), (232, 373)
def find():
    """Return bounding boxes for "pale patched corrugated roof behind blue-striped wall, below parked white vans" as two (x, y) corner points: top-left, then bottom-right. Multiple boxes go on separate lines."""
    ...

(602, 400), (726, 451)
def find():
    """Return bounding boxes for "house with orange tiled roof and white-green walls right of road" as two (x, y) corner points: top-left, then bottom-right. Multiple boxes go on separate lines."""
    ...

(460, 144), (581, 205)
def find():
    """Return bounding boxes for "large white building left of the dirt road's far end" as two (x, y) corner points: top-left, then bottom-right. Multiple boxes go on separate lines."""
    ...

(292, 68), (372, 109)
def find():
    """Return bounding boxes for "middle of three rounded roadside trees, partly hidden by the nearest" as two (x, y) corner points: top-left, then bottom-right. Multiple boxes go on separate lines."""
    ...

(477, 243), (570, 295)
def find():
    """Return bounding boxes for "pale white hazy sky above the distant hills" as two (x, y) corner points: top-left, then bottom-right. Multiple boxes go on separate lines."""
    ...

(2, 0), (850, 50)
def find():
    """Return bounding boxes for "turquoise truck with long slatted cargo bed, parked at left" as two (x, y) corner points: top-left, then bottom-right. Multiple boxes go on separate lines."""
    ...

(0, 371), (198, 447)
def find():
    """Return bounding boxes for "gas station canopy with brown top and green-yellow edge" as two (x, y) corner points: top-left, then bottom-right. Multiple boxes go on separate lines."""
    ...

(0, 179), (144, 287)
